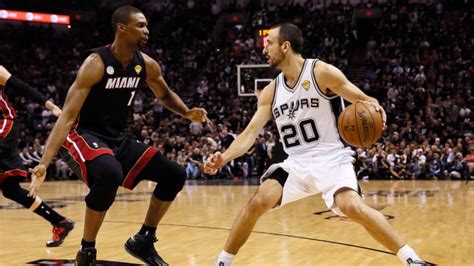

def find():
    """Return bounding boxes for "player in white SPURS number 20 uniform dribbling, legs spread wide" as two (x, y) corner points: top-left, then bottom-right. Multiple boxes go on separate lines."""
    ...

(204, 23), (428, 266)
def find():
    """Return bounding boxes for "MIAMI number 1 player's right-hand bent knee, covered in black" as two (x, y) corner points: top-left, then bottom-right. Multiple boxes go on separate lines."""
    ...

(153, 164), (186, 201)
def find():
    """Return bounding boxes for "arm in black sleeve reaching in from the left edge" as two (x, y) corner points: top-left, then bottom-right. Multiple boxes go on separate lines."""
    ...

(0, 66), (61, 116)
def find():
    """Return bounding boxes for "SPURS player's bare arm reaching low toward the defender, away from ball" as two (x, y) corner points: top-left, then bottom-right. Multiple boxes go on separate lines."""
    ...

(204, 81), (275, 174)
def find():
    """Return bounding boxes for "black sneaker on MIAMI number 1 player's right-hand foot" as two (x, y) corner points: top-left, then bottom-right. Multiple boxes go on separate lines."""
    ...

(125, 235), (168, 266)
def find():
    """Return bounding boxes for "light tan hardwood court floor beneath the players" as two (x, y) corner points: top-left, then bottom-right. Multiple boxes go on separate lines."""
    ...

(0, 181), (474, 266)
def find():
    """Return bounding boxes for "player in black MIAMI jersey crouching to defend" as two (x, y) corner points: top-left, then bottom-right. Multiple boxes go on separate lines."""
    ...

(31, 6), (208, 265)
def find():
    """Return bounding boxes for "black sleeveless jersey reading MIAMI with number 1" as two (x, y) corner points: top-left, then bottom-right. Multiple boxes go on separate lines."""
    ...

(77, 46), (146, 138)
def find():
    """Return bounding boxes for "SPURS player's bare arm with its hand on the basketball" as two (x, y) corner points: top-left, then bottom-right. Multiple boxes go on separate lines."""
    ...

(313, 61), (387, 124)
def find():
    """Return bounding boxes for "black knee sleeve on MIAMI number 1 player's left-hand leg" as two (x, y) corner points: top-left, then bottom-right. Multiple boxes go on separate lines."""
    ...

(85, 155), (123, 211)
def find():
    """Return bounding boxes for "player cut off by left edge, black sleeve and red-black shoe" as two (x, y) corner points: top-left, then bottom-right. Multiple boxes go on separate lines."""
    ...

(0, 66), (74, 247)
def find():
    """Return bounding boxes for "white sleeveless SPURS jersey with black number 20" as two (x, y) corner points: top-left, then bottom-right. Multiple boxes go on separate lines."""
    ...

(272, 59), (346, 157)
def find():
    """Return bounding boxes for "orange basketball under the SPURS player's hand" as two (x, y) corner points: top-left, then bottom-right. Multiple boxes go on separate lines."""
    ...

(337, 102), (383, 147)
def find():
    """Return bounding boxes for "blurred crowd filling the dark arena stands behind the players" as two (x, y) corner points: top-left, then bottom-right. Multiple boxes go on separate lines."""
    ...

(0, 0), (474, 179)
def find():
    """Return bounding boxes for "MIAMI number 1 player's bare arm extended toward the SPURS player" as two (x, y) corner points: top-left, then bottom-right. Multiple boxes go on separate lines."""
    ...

(142, 53), (210, 122)
